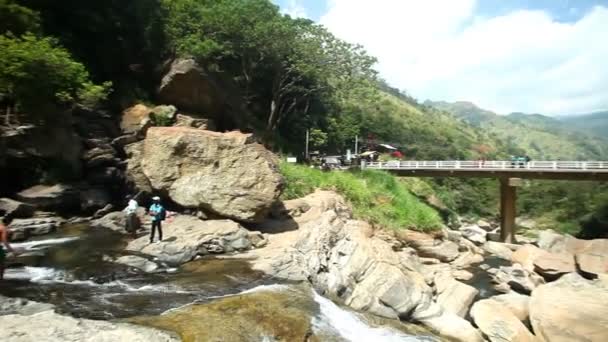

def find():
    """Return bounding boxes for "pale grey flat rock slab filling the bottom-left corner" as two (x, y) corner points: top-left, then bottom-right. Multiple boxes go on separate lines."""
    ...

(0, 311), (179, 342)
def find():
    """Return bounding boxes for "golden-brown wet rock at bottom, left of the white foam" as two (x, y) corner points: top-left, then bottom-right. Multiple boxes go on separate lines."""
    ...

(131, 289), (321, 342)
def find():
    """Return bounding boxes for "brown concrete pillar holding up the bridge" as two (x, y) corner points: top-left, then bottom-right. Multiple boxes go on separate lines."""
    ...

(500, 178), (521, 243)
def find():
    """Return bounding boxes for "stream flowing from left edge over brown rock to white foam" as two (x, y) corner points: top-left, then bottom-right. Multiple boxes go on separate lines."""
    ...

(0, 225), (439, 342)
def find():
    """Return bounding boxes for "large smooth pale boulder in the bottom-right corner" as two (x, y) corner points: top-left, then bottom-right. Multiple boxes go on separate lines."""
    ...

(530, 273), (608, 342)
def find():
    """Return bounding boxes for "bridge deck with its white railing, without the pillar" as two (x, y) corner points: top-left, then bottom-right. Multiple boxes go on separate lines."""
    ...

(362, 160), (608, 180)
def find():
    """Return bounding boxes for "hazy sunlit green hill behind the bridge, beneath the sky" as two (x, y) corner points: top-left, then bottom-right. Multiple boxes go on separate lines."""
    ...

(425, 101), (608, 160)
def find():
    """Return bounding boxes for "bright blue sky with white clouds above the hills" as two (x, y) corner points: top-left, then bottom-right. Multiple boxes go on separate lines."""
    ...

(274, 0), (608, 116)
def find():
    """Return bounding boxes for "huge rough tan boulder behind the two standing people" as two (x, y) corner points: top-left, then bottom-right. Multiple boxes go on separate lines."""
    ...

(129, 127), (283, 222)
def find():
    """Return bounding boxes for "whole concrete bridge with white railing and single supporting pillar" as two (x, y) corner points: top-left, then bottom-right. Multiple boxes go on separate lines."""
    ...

(361, 160), (608, 243)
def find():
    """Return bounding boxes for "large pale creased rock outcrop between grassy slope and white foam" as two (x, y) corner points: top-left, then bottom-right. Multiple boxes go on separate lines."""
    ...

(253, 191), (481, 341)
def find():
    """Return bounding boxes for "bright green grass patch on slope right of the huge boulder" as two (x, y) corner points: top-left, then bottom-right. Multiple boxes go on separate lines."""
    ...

(281, 163), (443, 231)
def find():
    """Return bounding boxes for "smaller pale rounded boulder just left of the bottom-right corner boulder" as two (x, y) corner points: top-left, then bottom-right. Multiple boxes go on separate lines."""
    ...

(471, 299), (536, 342)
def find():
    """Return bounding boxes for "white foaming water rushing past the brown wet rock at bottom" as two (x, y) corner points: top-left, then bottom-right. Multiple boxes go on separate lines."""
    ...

(312, 291), (436, 342)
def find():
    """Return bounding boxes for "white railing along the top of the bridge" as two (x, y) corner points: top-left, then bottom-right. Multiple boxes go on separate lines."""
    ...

(362, 160), (608, 172)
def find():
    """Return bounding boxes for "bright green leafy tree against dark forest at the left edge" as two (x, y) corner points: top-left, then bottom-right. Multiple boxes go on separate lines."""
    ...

(0, 34), (111, 120)
